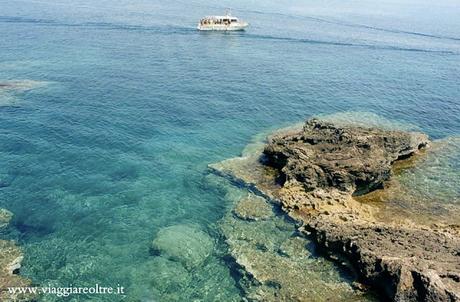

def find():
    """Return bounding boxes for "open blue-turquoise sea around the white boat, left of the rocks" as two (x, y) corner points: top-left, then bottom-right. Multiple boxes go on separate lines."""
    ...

(0, 0), (460, 301)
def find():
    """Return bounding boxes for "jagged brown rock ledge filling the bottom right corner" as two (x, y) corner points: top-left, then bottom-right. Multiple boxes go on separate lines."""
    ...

(303, 219), (460, 301)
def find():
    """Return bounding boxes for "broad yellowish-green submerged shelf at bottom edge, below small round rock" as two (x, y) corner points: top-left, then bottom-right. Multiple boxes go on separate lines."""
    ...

(220, 203), (368, 302)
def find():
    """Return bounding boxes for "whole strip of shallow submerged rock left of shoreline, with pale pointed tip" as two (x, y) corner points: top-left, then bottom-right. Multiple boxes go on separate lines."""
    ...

(210, 132), (375, 302)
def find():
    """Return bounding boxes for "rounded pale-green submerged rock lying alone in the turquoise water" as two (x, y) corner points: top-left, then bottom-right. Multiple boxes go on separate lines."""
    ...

(152, 224), (214, 270)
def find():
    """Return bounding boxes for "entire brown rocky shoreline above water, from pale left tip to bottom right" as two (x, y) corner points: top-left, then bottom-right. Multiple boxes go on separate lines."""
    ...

(211, 119), (460, 301)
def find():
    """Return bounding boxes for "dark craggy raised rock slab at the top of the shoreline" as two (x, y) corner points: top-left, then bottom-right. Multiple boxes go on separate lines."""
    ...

(264, 119), (428, 193)
